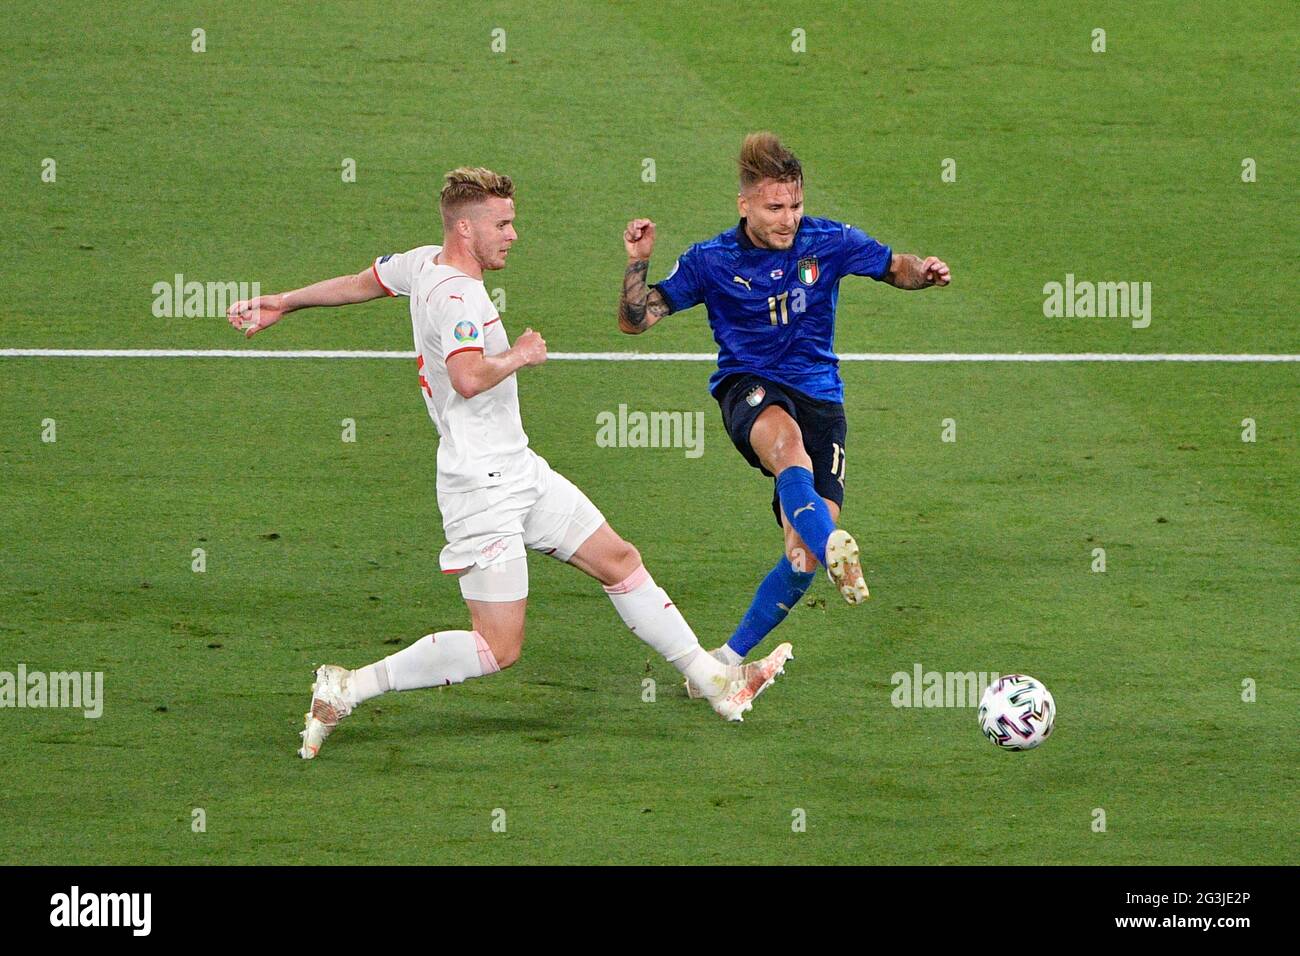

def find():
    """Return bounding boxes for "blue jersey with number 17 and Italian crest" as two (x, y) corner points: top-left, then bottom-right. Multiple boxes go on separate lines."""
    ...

(655, 216), (893, 403)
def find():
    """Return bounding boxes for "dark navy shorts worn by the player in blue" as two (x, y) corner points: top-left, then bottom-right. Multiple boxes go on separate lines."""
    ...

(714, 373), (849, 524)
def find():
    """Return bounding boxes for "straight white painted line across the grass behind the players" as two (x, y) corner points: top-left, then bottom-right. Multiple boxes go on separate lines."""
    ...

(0, 349), (1300, 362)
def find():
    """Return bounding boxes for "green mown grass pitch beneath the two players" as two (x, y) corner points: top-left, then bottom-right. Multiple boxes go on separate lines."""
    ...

(0, 1), (1300, 864)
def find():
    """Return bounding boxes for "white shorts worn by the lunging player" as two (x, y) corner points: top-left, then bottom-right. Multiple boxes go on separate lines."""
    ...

(438, 454), (605, 602)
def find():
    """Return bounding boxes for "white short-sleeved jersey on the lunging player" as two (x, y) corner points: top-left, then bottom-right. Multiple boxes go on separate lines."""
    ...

(373, 246), (536, 493)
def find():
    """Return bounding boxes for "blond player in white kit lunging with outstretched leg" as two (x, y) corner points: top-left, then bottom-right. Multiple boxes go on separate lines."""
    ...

(228, 168), (792, 760)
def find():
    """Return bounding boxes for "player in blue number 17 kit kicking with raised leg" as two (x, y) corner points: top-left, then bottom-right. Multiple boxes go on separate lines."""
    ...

(619, 133), (950, 696)
